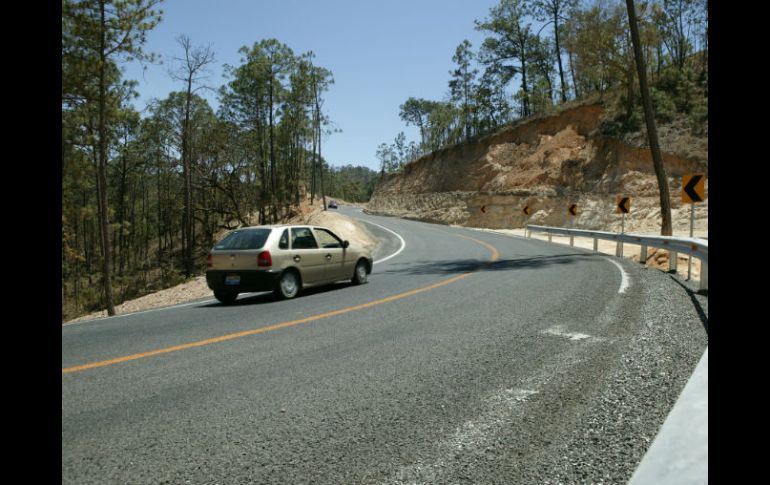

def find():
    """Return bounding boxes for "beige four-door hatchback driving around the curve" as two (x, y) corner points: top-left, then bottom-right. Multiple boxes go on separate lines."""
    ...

(206, 225), (373, 304)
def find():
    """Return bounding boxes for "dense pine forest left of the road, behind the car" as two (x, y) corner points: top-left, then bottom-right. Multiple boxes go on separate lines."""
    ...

(61, 0), (348, 321)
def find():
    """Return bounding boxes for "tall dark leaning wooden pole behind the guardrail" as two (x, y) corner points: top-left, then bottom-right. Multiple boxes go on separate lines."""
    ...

(626, 0), (672, 236)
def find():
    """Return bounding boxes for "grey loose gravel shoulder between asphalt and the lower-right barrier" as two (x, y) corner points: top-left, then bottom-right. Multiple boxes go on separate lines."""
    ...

(522, 268), (708, 485)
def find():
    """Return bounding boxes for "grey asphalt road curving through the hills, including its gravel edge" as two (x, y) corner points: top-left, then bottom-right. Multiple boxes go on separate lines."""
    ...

(62, 208), (707, 484)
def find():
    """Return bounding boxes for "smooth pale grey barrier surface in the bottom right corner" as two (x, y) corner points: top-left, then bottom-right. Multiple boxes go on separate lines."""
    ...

(628, 347), (708, 485)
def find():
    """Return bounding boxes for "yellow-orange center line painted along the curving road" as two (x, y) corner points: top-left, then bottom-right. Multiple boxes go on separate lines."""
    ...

(62, 234), (500, 374)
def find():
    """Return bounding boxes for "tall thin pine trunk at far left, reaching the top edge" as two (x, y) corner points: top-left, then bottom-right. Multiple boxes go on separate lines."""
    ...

(97, 1), (115, 316)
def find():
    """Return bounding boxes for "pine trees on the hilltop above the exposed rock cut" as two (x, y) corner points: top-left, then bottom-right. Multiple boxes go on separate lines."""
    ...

(376, 0), (708, 173)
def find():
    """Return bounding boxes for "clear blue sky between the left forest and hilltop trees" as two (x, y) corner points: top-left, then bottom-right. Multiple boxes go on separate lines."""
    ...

(125, 0), (498, 170)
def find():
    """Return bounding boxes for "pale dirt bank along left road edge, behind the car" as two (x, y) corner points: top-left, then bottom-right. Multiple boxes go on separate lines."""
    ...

(64, 201), (377, 323)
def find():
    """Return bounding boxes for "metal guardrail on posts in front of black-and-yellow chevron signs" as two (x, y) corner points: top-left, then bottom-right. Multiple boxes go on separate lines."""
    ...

(525, 225), (709, 291)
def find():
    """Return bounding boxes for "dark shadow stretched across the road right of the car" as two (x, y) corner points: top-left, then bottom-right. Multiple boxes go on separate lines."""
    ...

(378, 253), (605, 275)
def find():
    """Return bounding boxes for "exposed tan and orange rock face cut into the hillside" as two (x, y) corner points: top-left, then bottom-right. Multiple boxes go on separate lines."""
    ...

(367, 105), (708, 233)
